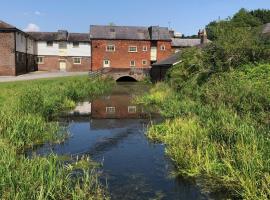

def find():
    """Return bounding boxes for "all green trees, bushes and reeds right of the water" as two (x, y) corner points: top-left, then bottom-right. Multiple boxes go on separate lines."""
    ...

(137, 10), (270, 199)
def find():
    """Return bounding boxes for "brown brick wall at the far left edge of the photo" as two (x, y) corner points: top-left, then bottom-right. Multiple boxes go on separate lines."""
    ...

(0, 32), (16, 76)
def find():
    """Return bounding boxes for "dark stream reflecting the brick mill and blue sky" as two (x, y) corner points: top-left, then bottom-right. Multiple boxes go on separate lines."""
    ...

(30, 84), (211, 200)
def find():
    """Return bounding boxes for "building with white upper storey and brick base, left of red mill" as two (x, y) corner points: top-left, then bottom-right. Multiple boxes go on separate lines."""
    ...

(28, 30), (91, 72)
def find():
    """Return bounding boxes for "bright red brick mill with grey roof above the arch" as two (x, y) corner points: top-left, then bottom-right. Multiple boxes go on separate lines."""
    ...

(90, 25), (172, 71)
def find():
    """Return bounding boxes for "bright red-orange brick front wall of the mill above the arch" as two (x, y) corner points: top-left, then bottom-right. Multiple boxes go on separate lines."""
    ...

(91, 40), (151, 71)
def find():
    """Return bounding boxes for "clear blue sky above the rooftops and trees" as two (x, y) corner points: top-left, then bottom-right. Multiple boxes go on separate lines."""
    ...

(0, 0), (270, 35)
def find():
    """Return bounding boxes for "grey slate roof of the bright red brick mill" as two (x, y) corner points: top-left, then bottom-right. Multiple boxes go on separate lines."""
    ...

(90, 25), (171, 40)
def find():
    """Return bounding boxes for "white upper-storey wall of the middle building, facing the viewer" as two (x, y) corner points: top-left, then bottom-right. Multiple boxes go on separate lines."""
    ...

(37, 41), (91, 57)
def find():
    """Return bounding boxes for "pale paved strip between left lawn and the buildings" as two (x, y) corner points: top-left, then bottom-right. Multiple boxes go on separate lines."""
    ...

(0, 71), (88, 83)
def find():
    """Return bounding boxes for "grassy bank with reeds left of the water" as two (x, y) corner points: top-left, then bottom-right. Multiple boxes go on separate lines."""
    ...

(0, 76), (112, 199)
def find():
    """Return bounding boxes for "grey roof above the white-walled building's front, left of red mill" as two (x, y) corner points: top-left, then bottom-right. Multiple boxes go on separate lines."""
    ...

(28, 30), (90, 42)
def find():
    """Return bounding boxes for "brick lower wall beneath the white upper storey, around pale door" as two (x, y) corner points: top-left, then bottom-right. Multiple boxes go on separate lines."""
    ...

(38, 56), (91, 72)
